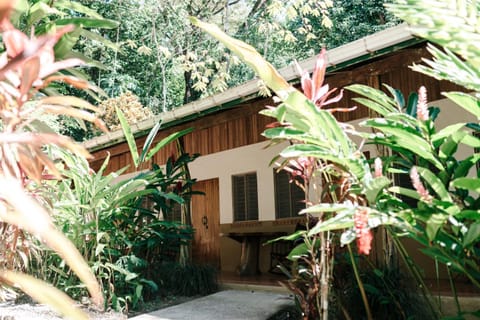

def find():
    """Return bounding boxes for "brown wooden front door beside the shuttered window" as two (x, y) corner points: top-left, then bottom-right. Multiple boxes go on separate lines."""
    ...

(192, 179), (220, 268)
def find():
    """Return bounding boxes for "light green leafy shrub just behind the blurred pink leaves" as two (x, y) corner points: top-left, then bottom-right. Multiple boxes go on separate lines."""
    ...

(35, 149), (155, 307)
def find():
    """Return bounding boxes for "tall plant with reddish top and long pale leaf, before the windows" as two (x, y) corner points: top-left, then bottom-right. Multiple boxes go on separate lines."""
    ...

(192, 18), (372, 319)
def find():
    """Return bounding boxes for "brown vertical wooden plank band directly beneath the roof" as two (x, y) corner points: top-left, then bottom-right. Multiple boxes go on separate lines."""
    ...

(91, 45), (461, 172)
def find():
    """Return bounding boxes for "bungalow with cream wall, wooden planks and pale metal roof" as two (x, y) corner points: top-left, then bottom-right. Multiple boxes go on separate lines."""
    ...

(85, 25), (468, 284)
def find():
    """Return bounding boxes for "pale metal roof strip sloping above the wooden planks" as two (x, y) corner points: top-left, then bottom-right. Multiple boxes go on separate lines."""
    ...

(83, 24), (421, 152)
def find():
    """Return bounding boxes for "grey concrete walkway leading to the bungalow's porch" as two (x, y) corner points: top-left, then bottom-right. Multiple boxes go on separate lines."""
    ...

(130, 290), (294, 320)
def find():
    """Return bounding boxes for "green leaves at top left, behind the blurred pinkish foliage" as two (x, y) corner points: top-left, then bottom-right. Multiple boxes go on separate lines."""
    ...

(12, 0), (124, 141)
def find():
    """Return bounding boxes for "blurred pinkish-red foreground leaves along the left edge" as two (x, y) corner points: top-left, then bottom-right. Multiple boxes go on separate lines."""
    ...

(0, 1), (104, 319)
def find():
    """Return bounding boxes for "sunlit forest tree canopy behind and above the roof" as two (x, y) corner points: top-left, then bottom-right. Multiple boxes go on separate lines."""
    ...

(13, 0), (397, 140)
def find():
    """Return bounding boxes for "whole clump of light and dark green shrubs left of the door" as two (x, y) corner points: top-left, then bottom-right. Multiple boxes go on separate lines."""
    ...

(30, 107), (201, 311)
